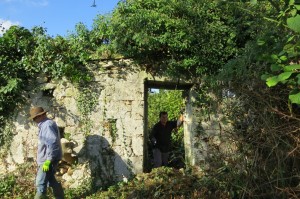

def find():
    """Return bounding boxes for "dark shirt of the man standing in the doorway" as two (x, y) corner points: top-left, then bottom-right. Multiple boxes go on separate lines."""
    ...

(152, 121), (177, 153)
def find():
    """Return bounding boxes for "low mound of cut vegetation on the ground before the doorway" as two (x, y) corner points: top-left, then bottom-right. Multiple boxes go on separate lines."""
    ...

(88, 167), (230, 199)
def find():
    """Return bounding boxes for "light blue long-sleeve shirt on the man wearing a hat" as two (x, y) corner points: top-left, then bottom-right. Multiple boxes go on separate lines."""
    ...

(37, 118), (62, 165)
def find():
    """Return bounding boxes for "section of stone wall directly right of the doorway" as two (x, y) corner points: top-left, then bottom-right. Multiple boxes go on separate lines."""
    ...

(184, 88), (238, 170)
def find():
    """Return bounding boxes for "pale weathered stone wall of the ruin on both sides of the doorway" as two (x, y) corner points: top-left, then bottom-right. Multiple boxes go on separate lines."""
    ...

(0, 60), (232, 187)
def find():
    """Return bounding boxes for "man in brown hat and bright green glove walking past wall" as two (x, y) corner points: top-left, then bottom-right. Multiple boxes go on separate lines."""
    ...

(29, 107), (64, 199)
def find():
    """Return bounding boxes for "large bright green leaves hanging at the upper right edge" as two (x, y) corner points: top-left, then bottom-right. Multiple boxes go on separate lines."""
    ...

(261, 1), (300, 104)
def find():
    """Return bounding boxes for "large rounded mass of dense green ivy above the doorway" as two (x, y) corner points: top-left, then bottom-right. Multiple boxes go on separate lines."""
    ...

(111, 0), (245, 78)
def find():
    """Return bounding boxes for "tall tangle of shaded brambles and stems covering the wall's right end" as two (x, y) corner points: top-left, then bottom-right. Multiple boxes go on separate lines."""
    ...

(214, 1), (299, 198)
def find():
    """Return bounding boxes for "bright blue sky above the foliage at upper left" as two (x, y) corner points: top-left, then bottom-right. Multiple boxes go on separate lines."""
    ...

(0, 0), (119, 36)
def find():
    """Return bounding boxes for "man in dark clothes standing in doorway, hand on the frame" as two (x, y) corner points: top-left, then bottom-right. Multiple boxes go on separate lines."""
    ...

(151, 112), (183, 168)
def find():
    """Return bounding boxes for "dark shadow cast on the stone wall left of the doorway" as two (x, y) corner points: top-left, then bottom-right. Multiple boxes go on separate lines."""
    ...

(78, 135), (133, 189)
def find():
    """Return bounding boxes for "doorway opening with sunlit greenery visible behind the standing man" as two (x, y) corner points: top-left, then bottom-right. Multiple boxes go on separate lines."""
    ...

(144, 80), (192, 172)
